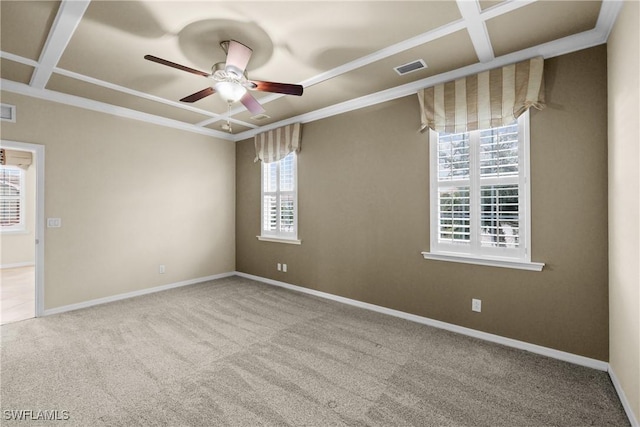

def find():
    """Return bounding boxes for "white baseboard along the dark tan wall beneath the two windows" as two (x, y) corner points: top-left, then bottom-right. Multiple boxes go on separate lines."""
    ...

(236, 272), (609, 372)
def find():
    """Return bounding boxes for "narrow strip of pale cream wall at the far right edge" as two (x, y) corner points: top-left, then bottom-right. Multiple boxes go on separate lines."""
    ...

(607, 2), (640, 420)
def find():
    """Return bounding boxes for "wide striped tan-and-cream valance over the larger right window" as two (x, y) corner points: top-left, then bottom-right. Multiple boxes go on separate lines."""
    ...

(418, 57), (544, 133)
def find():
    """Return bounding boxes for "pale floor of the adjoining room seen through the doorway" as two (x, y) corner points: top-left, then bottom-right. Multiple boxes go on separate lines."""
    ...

(0, 267), (36, 325)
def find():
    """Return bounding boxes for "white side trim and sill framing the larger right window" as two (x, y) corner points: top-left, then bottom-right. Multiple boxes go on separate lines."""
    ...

(422, 111), (544, 271)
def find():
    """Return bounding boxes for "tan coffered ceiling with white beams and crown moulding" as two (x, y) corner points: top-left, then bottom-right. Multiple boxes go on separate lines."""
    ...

(0, 0), (621, 140)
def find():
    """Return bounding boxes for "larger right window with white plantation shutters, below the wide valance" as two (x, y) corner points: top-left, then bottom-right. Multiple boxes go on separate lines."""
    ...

(430, 112), (531, 262)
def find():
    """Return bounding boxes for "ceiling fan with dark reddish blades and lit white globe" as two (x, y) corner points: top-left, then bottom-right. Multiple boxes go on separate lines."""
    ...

(144, 40), (303, 114)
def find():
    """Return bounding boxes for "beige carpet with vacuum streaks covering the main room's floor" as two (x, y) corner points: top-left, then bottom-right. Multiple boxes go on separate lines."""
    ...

(0, 277), (629, 426)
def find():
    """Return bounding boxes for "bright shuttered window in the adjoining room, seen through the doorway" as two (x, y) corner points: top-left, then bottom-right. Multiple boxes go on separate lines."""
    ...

(0, 166), (25, 232)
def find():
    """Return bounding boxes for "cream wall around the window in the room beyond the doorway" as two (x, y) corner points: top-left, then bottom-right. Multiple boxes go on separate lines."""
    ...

(0, 159), (36, 267)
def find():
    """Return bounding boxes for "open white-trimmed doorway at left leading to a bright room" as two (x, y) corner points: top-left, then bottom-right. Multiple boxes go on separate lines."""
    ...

(0, 140), (44, 324)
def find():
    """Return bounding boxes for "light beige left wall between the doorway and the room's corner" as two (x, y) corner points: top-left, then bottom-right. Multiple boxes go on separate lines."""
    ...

(2, 92), (235, 309)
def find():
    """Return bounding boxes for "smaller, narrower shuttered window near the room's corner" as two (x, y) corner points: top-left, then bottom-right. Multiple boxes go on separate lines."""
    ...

(259, 152), (299, 243)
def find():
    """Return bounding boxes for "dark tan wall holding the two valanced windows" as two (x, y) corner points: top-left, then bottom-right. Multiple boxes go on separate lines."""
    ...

(236, 46), (608, 360)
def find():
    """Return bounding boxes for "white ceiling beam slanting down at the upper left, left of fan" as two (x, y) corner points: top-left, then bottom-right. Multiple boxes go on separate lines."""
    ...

(29, 0), (90, 89)
